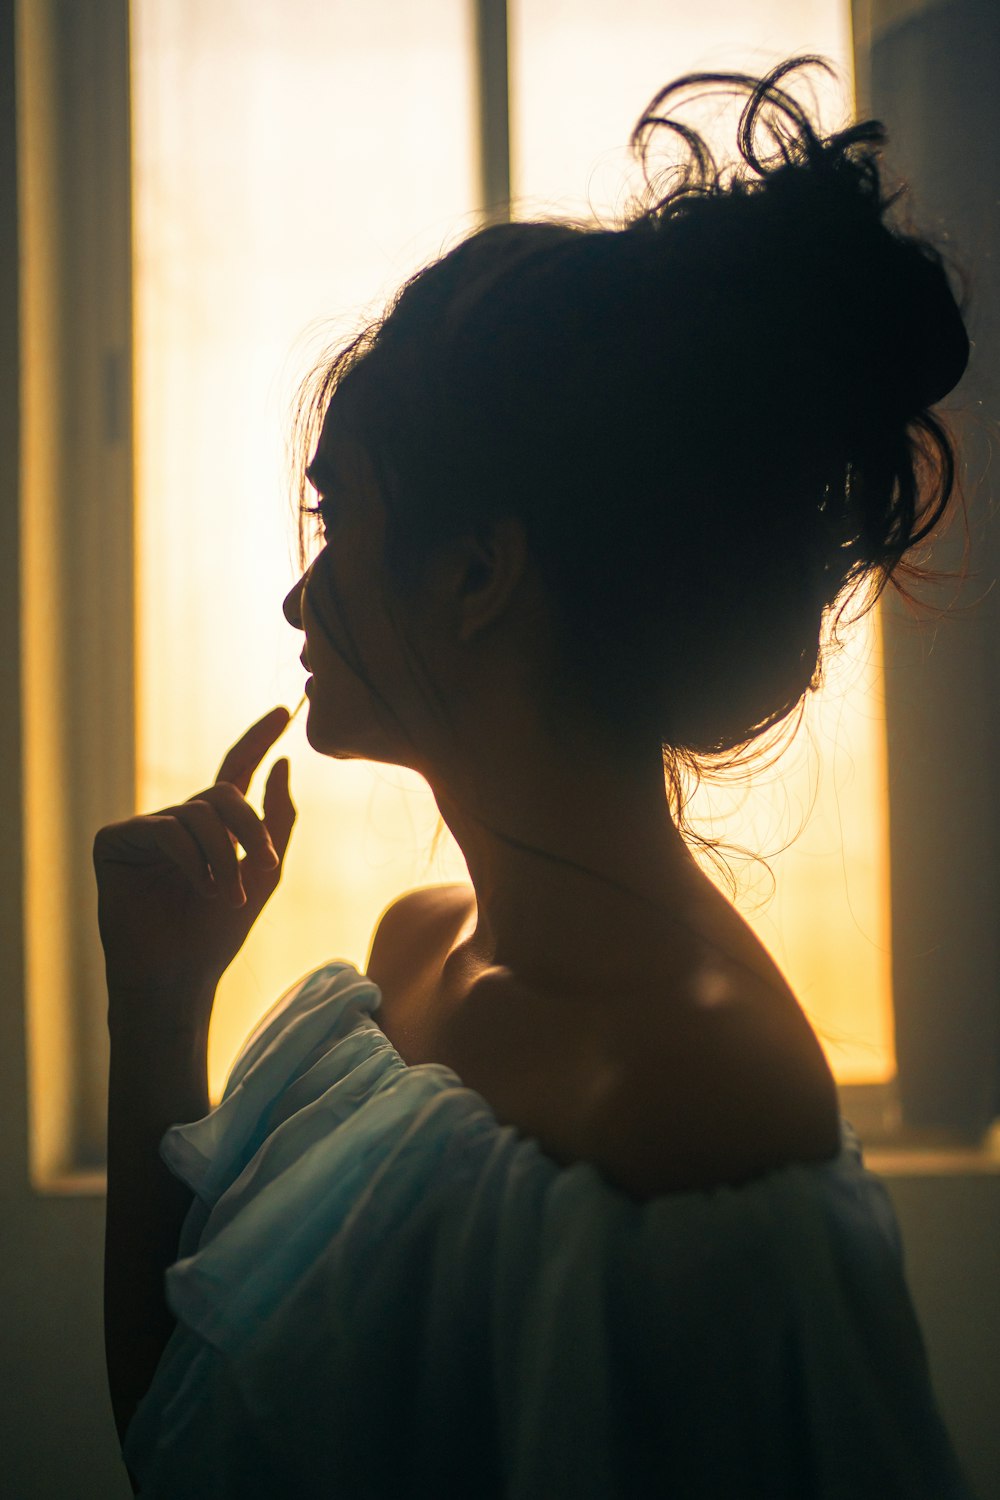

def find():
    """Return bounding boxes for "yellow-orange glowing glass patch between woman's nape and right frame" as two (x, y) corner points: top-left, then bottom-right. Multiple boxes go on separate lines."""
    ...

(693, 614), (895, 1083)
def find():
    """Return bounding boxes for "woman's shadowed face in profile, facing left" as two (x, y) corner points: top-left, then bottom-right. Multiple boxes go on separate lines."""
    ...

(283, 416), (431, 765)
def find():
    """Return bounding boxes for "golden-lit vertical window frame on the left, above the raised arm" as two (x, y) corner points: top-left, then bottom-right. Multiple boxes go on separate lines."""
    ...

(16, 0), (136, 1193)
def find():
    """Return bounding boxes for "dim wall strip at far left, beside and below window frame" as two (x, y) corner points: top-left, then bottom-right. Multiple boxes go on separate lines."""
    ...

(0, 0), (130, 1500)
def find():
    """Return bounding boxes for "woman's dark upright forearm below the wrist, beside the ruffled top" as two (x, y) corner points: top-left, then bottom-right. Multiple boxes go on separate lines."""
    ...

(103, 995), (213, 1440)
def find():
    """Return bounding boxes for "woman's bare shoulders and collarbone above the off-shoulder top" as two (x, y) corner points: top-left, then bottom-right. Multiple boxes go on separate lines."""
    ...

(367, 885), (841, 1199)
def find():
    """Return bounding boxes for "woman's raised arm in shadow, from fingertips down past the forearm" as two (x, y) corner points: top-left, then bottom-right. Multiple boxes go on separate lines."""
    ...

(94, 708), (295, 1470)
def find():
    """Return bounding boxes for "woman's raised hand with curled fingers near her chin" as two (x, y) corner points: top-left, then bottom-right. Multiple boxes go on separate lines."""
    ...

(93, 708), (295, 1014)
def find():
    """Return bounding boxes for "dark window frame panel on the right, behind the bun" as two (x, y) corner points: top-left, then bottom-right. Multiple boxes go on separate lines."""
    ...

(852, 0), (1000, 1163)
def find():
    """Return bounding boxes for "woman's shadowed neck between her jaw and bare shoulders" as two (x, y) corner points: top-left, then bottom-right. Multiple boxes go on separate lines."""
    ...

(430, 738), (705, 986)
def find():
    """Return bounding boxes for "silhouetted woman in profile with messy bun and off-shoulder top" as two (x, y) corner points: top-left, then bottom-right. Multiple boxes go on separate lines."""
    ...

(94, 60), (969, 1500)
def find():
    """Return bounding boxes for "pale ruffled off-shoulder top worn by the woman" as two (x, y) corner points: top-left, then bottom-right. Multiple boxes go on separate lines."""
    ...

(124, 963), (970, 1500)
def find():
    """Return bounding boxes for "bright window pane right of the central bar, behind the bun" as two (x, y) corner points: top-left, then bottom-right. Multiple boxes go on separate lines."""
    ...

(510, 0), (895, 1083)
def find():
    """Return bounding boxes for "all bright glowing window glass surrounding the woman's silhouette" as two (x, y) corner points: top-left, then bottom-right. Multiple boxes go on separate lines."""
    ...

(132, 0), (892, 1098)
